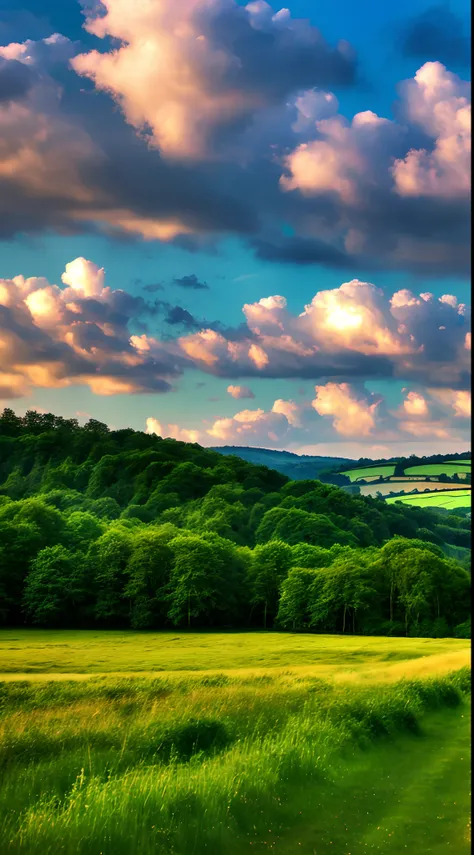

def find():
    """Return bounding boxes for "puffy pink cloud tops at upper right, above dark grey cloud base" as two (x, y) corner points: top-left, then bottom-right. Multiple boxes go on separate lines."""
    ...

(280, 62), (471, 207)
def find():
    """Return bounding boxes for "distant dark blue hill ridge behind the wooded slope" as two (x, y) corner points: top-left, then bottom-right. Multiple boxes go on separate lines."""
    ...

(211, 445), (356, 481)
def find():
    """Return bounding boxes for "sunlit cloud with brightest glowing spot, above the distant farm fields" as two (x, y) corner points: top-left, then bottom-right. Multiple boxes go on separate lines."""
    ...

(178, 279), (470, 389)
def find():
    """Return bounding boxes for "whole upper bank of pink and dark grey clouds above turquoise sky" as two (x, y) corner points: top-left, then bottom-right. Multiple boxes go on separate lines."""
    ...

(0, 25), (470, 276)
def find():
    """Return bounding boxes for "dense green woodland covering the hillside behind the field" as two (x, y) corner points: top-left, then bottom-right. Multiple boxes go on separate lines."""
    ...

(0, 410), (470, 636)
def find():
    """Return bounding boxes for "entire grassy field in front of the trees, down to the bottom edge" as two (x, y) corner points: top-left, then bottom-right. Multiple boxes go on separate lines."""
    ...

(0, 630), (470, 855)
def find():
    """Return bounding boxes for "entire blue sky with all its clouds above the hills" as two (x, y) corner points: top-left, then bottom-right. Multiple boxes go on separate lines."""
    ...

(0, 0), (471, 459)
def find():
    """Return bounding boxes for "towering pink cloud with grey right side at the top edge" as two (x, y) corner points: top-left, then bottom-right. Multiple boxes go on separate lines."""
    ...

(72, 0), (355, 160)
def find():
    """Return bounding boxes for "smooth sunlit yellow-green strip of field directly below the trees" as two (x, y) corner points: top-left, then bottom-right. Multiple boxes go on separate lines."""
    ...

(0, 629), (469, 677)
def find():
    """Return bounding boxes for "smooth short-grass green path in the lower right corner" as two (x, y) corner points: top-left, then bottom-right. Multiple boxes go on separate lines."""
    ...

(274, 706), (470, 855)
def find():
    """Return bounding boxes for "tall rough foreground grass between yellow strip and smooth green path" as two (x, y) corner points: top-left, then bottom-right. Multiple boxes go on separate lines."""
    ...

(0, 669), (469, 855)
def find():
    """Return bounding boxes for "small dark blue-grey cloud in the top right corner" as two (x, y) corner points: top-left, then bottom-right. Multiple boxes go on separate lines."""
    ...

(399, 3), (471, 68)
